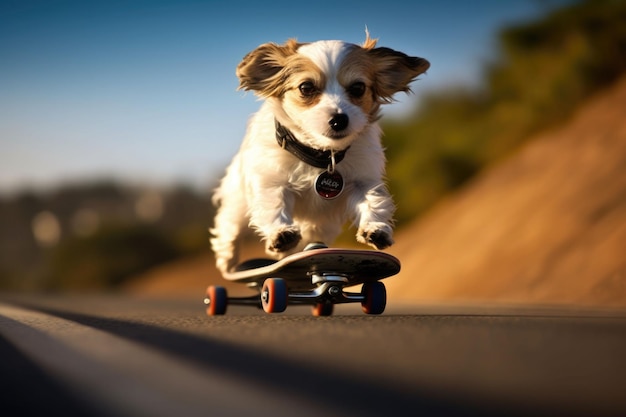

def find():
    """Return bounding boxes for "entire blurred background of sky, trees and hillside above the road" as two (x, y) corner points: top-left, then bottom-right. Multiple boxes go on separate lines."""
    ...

(0, 0), (626, 307)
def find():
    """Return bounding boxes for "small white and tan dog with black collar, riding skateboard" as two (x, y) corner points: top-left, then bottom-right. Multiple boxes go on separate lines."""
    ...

(211, 35), (430, 272)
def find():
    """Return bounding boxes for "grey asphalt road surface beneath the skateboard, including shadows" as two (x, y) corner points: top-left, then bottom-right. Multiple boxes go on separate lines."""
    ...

(0, 294), (626, 417)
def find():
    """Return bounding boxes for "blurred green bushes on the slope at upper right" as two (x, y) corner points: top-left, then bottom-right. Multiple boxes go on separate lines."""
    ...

(384, 0), (626, 224)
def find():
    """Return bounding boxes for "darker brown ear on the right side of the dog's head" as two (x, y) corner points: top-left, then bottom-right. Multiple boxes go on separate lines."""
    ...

(367, 47), (430, 102)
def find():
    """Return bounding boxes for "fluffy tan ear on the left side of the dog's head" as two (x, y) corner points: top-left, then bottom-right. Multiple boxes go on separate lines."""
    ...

(236, 39), (300, 97)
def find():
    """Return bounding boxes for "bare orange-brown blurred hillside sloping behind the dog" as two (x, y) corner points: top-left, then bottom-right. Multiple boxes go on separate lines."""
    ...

(125, 78), (626, 307)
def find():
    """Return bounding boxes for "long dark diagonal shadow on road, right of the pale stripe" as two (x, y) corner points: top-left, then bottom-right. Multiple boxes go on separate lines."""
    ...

(14, 305), (500, 416)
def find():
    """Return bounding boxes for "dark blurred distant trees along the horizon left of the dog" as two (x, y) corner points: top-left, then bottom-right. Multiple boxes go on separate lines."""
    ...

(0, 182), (213, 291)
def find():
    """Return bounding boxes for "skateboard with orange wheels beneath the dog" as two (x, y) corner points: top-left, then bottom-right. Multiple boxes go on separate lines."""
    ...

(204, 244), (400, 316)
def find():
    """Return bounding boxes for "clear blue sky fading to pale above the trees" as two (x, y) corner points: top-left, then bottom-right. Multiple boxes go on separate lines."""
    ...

(0, 0), (564, 193)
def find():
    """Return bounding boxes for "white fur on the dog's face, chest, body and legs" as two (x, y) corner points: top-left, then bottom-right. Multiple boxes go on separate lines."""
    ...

(211, 36), (427, 272)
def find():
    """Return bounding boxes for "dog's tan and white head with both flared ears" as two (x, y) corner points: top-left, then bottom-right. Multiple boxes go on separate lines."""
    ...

(237, 36), (430, 150)
